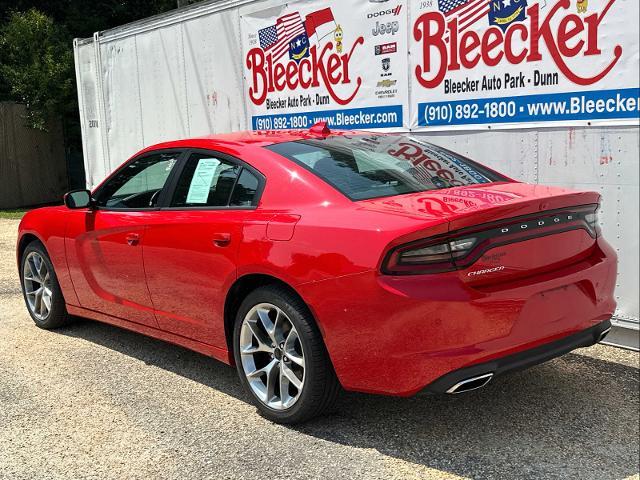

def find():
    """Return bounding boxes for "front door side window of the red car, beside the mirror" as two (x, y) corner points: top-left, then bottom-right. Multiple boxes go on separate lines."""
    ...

(96, 152), (180, 209)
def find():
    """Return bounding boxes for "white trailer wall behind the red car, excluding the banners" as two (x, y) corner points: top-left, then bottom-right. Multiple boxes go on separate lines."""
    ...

(74, 0), (640, 348)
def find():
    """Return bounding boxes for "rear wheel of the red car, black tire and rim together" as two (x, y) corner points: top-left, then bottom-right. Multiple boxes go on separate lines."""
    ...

(233, 285), (339, 424)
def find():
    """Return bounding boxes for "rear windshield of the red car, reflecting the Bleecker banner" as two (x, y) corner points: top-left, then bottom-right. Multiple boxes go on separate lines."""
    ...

(265, 135), (507, 200)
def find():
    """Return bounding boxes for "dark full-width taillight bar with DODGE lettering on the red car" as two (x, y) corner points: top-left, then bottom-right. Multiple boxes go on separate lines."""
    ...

(382, 205), (599, 275)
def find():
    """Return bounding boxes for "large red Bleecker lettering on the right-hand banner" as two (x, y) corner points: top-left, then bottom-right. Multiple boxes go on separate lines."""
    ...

(413, 0), (622, 88)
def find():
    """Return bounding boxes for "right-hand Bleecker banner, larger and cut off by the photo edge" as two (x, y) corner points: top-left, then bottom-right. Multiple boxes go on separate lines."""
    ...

(410, 0), (640, 130)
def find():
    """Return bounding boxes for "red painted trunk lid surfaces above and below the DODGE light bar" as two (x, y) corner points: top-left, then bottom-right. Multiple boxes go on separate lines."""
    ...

(358, 182), (600, 285)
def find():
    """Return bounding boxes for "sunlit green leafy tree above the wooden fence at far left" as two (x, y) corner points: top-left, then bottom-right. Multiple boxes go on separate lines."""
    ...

(0, 8), (77, 130)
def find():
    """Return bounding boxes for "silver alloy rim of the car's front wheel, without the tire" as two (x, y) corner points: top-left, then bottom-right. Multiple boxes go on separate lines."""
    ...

(22, 252), (53, 321)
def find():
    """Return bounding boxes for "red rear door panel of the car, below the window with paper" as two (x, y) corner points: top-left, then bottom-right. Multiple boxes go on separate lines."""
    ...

(144, 210), (255, 348)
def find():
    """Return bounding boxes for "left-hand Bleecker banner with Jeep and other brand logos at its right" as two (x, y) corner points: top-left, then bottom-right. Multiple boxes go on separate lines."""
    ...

(241, 0), (409, 130)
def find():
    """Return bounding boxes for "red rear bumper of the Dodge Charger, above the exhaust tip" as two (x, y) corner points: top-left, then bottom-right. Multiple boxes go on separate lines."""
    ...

(298, 239), (617, 396)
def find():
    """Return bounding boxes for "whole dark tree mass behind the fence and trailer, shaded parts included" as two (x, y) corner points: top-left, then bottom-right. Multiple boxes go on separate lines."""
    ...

(0, 0), (185, 188)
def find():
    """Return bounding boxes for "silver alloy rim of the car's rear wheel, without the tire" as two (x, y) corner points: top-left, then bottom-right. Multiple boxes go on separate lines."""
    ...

(239, 303), (305, 410)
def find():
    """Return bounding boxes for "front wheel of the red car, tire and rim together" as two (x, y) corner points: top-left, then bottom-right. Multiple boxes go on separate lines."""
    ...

(20, 241), (70, 330)
